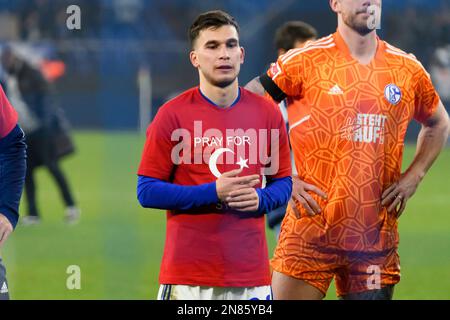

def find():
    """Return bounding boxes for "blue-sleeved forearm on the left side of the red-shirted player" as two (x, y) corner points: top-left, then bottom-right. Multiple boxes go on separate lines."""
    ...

(137, 176), (219, 210)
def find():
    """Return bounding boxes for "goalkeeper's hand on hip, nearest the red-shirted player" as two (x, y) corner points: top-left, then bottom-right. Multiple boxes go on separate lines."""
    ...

(289, 175), (327, 219)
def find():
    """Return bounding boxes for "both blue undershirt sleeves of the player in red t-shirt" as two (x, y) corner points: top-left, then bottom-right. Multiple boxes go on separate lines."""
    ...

(137, 176), (292, 214)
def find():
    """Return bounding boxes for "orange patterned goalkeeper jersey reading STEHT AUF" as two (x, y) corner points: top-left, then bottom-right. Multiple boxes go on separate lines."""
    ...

(267, 32), (439, 252)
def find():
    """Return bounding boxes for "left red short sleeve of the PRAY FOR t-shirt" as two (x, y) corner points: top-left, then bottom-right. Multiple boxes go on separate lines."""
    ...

(138, 107), (176, 181)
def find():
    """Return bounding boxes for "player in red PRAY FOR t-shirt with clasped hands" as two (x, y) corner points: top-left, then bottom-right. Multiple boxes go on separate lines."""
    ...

(137, 11), (292, 300)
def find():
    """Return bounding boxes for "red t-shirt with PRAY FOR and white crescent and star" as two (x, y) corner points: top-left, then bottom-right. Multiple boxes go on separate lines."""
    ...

(138, 88), (291, 287)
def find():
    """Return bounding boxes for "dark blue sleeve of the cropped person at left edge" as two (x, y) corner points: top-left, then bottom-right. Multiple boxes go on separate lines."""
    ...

(0, 126), (26, 227)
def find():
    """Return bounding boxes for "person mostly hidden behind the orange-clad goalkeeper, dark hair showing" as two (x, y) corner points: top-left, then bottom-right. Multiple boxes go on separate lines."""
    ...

(267, 21), (320, 239)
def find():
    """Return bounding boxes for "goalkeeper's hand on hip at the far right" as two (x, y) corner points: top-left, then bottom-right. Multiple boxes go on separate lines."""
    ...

(381, 172), (421, 218)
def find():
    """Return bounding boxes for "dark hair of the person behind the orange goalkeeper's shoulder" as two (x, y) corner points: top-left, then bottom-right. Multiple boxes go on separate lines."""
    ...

(275, 21), (317, 51)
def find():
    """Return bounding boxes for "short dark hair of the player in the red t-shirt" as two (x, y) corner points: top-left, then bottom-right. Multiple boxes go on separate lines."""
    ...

(189, 10), (239, 48)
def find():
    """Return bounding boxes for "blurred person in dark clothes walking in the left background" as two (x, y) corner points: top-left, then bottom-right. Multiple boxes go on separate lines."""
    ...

(1, 47), (80, 225)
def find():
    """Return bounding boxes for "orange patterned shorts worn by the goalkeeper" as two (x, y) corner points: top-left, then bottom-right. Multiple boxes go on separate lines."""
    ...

(271, 207), (400, 297)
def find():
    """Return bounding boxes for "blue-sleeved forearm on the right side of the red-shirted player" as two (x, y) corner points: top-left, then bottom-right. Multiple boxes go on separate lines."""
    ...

(256, 177), (292, 213)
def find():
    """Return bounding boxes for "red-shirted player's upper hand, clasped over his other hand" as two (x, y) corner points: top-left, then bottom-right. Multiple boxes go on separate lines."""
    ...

(216, 168), (260, 202)
